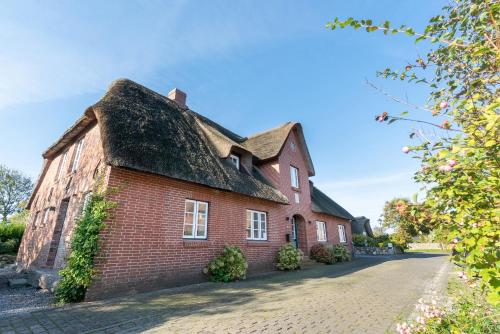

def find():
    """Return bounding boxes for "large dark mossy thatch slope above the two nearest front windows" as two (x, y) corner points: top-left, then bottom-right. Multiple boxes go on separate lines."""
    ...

(90, 79), (288, 204)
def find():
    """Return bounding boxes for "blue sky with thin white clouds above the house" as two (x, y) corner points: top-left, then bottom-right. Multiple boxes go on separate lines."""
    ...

(0, 0), (444, 222)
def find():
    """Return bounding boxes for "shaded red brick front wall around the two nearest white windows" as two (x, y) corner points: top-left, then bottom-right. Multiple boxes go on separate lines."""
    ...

(87, 168), (285, 300)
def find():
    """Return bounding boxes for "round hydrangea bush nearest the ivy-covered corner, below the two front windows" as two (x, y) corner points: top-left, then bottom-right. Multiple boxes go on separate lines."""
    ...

(203, 245), (248, 282)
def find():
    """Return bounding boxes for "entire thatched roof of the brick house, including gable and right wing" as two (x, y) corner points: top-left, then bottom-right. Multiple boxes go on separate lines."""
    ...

(35, 79), (354, 211)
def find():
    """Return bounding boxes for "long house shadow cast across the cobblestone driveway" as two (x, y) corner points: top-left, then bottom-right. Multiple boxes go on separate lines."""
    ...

(0, 253), (446, 333)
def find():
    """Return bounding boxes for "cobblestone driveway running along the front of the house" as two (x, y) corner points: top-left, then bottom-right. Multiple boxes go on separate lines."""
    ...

(0, 255), (447, 333)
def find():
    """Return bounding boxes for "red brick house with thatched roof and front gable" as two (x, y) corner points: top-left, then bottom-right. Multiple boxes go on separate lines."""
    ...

(17, 79), (354, 300)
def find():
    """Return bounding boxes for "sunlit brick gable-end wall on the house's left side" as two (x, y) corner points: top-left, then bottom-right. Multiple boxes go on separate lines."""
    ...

(17, 124), (103, 268)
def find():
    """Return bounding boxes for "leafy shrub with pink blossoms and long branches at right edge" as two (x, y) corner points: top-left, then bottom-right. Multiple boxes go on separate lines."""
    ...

(327, 0), (500, 304)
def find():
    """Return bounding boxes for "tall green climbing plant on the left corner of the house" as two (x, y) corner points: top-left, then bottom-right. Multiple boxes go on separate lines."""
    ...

(55, 190), (115, 303)
